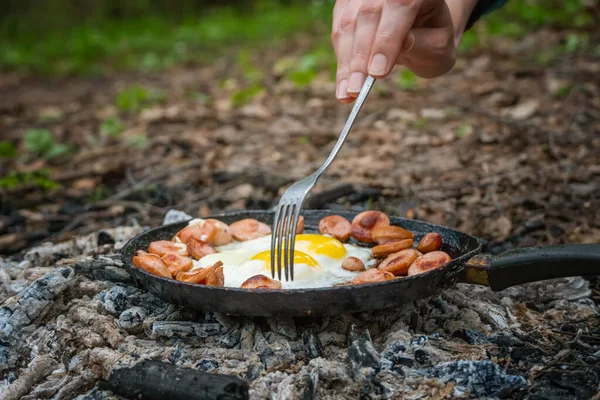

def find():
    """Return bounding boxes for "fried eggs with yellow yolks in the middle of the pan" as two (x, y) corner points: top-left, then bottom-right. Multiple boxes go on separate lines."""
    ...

(194, 233), (375, 289)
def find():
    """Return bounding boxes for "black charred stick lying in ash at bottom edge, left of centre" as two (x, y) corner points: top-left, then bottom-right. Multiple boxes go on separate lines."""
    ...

(102, 360), (248, 400)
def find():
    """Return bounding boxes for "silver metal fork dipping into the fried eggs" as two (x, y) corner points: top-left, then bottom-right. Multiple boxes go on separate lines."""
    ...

(271, 76), (375, 281)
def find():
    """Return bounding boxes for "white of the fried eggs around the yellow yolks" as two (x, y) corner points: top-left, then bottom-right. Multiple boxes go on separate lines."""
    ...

(194, 235), (375, 289)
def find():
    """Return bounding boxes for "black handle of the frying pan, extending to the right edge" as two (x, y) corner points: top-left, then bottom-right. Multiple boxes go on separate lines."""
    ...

(465, 243), (600, 291)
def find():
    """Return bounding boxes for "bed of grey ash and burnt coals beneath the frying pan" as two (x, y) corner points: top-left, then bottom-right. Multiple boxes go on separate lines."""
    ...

(0, 223), (600, 400)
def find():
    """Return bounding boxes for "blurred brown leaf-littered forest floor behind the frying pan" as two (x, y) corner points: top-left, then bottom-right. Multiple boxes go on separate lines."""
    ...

(0, 24), (600, 254)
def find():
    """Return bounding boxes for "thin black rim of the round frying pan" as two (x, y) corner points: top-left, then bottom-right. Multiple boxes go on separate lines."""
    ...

(119, 209), (482, 295)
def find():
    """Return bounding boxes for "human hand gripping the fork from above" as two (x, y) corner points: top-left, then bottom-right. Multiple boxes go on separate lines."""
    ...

(331, 0), (468, 103)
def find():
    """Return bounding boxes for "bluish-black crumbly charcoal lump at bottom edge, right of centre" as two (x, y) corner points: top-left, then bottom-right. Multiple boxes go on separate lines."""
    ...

(429, 361), (529, 396)
